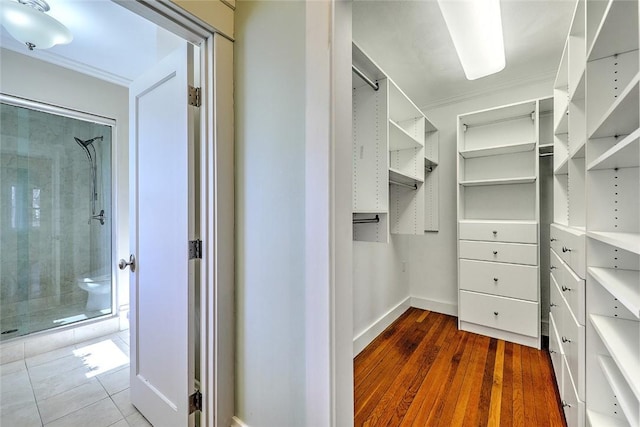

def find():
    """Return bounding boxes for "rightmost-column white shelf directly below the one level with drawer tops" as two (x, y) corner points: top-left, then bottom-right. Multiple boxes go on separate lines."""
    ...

(589, 267), (640, 319)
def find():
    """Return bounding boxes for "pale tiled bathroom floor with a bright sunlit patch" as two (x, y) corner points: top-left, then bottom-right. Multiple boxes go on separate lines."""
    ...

(0, 331), (151, 427)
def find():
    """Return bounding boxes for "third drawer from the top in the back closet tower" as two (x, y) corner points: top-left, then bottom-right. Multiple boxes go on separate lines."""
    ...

(460, 259), (538, 301)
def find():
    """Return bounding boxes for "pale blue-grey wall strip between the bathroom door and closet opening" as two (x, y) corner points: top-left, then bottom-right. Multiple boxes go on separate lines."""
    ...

(234, 1), (306, 427)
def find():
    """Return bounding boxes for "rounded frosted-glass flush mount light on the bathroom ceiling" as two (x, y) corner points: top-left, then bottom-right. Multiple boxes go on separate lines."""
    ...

(0, 0), (73, 50)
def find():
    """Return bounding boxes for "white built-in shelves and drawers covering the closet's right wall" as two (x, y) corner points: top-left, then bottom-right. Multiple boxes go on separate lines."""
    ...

(549, 0), (640, 427)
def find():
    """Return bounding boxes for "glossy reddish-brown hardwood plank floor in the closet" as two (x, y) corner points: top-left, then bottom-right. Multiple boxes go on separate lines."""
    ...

(354, 308), (566, 427)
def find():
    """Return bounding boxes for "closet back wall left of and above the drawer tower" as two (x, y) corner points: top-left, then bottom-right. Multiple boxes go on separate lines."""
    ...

(390, 81), (553, 315)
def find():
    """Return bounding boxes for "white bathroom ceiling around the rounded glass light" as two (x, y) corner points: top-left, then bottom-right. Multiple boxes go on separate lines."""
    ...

(0, 0), (181, 86)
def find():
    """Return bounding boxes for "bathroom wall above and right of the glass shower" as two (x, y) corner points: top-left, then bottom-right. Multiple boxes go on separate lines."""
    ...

(0, 49), (129, 316)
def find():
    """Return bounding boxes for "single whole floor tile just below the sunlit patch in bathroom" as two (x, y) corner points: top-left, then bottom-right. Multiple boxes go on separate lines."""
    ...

(38, 378), (108, 424)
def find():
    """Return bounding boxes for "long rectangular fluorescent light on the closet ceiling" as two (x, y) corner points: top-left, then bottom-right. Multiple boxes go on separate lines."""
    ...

(438, 0), (505, 80)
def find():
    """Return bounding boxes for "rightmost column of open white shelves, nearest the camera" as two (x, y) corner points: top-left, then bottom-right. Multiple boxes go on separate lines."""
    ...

(585, 0), (640, 426)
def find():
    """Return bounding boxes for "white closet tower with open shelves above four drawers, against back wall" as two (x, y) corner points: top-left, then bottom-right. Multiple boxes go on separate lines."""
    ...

(457, 100), (541, 348)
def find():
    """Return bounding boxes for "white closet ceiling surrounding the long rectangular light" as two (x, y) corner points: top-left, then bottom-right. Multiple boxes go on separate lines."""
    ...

(353, 0), (575, 108)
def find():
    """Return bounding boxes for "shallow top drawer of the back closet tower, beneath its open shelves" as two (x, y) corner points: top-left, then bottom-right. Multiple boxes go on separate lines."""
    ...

(459, 221), (538, 243)
